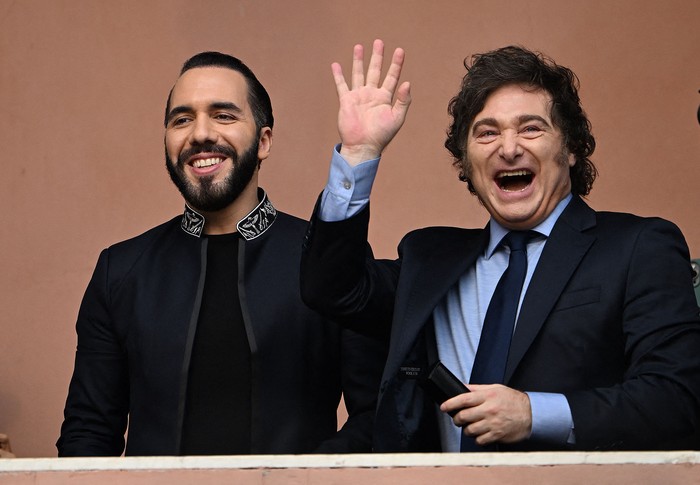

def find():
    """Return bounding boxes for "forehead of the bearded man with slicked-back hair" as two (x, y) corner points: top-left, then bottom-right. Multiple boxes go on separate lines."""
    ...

(170, 67), (248, 108)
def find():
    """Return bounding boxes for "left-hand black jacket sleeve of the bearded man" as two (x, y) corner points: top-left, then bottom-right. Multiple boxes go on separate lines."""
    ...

(56, 250), (129, 456)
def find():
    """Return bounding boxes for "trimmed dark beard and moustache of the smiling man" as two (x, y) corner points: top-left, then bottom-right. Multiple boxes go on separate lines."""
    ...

(165, 139), (259, 212)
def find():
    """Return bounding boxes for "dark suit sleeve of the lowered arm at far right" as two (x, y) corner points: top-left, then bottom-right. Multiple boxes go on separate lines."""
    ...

(566, 219), (700, 449)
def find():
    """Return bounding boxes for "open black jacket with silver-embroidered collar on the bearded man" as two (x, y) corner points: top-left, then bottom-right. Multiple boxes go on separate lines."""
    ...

(57, 187), (385, 456)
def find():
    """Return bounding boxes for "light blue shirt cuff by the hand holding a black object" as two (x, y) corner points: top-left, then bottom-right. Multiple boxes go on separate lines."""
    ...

(526, 392), (575, 445)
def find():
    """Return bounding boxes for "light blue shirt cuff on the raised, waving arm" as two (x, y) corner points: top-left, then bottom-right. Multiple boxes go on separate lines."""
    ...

(318, 145), (379, 222)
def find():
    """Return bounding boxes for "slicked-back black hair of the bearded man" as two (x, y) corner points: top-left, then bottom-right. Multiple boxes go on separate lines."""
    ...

(165, 51), (275, 133)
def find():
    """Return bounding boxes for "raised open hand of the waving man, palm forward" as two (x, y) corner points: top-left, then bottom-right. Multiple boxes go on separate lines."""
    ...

(331, 39), (411, 165)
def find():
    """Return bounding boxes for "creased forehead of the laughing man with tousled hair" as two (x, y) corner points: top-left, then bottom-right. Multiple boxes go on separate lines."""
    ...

(474, 84), (552, 122)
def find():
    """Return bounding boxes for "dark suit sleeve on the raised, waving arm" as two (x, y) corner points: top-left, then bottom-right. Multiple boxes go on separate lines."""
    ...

(300, 195), (400, 339)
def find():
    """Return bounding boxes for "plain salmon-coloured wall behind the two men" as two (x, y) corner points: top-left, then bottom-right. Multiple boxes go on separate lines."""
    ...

(0, 0), (700, 457)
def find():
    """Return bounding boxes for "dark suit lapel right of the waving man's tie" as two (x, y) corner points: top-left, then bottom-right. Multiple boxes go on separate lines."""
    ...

(504, 196), (595, 383)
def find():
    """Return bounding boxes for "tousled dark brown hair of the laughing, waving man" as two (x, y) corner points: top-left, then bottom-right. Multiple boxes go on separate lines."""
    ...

(445, 46), (598, 196)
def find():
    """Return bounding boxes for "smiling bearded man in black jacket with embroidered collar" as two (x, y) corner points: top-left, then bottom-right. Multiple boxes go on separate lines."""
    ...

(57, 52), (385, 456)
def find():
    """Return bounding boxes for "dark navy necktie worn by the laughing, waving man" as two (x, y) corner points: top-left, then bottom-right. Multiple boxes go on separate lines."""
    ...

(461, 231), (535, 451)
